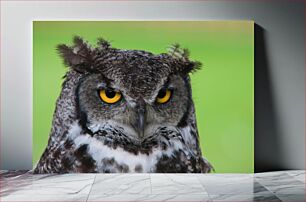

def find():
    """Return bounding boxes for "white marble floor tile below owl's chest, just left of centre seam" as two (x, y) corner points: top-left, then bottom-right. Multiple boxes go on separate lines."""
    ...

(90, 173), (151, 195)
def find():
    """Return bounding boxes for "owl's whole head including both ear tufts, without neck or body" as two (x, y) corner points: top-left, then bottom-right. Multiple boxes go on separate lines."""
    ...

(58, 37), (200, 144)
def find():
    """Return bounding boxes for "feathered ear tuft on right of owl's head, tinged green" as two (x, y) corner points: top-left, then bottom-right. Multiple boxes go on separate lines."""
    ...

(167, 43), (202, 74)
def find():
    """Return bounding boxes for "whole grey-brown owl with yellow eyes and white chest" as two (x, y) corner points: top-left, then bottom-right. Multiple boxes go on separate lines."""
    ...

(33, 36), (213, 173)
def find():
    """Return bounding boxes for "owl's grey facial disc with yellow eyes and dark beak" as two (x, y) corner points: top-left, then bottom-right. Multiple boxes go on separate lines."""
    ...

(76, 66), (191, 141)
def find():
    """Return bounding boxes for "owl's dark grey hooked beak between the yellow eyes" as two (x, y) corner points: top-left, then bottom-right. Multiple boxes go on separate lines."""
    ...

(133, 99), (146, 139)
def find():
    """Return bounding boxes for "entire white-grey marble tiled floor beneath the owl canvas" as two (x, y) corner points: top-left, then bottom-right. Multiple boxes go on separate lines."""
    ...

(0, 170), (305, 202)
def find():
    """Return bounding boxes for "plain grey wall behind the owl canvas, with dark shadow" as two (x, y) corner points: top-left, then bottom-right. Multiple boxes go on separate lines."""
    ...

(0, 0), (305, 171)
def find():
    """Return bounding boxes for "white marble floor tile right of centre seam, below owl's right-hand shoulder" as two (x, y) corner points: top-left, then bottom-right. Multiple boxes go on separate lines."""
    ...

(150, 174), (207, 195)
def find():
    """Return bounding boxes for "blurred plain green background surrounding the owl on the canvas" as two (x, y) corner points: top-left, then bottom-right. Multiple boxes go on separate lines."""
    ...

(33, 21), (254, 173)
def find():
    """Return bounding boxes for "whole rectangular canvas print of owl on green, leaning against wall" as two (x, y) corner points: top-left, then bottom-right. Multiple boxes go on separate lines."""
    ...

(33, 21), (254, 174)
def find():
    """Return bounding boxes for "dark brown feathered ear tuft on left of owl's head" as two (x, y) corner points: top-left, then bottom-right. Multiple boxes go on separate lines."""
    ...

(57, 36), (94, 72)
